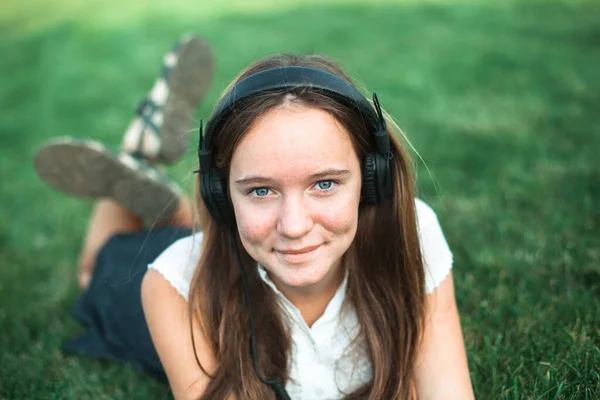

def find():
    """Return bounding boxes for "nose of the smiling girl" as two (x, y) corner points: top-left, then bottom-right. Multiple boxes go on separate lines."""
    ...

(277, 195), (313, 239)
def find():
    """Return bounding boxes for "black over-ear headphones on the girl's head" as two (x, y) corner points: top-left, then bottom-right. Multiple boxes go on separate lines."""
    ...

(196, 67), (394, 227)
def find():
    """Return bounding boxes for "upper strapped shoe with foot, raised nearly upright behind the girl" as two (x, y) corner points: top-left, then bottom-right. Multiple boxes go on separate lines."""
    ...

(123, 35), (214, 164)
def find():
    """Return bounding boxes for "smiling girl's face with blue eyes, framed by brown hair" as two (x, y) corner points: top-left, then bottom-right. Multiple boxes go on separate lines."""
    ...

(229, 105), (361, 293)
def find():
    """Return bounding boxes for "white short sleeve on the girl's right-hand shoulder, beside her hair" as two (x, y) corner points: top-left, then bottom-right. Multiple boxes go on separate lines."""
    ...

(415, 199), (452, 294)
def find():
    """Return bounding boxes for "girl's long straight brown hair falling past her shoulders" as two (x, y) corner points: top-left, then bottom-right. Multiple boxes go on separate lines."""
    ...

(189, 54), (425, 400)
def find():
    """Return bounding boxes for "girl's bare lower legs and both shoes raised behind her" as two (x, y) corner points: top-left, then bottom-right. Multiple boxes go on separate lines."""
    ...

(34, 37), (214, 289)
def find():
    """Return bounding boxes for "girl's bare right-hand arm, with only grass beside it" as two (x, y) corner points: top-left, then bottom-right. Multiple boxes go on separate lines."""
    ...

(415, 272), (474, 400)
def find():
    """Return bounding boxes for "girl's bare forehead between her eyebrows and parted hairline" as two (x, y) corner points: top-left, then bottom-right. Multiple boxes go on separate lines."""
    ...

(230, 105), (358, 178)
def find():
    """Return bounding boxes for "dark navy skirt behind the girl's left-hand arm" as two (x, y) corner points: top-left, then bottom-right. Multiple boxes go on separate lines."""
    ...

(64, 226), (192, 381)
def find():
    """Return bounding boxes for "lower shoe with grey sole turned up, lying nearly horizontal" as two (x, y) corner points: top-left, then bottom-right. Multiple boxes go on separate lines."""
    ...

(34, 137), (181, 223)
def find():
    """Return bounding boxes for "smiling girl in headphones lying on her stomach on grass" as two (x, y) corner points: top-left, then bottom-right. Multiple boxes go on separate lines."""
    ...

(38, 46), (473, 400)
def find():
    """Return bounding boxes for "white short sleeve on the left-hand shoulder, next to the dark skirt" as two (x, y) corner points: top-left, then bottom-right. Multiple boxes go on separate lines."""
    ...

(148, 232), (203, 301)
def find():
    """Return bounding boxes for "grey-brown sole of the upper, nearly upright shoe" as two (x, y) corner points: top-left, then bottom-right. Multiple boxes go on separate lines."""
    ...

(159, 37), (214, 164)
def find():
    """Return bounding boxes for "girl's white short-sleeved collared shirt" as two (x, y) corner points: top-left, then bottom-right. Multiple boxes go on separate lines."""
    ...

(148, 199), (452, 400)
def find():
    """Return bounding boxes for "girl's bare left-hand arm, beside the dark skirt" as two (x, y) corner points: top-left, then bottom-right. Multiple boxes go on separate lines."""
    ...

(142, 270), (215, 400)
